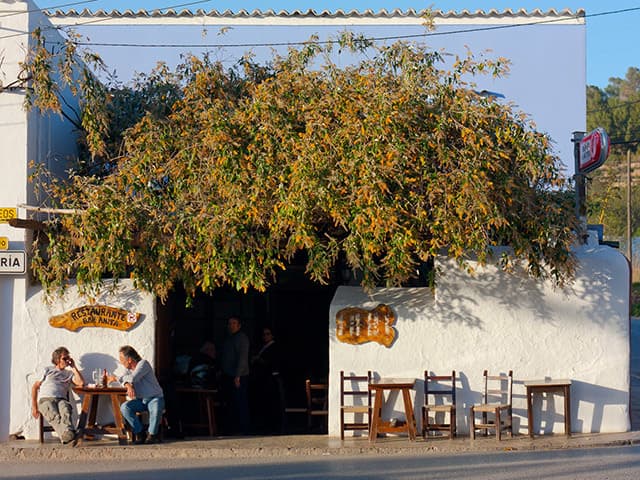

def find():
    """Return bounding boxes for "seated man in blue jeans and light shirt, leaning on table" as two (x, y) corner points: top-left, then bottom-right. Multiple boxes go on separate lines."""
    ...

(114, 345), (164, 445)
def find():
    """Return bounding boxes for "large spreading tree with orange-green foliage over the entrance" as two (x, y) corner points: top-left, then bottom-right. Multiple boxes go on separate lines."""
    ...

(25, 30), (576, 298)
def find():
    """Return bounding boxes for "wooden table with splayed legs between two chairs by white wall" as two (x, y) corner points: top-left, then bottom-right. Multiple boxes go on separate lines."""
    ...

(369, 378), (416, 442)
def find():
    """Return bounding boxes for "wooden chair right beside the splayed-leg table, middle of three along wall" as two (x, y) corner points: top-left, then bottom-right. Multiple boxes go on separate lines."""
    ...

(422, 370), (456, 440)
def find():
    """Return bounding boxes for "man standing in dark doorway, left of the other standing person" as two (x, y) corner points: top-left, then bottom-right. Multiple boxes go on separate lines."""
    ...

(222, 316), (249, 435)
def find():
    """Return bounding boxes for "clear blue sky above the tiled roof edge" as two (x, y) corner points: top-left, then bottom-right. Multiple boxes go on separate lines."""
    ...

(36, 0), (640, 87)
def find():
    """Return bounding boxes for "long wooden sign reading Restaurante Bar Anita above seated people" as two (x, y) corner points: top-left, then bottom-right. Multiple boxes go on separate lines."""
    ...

(49, 305), (140, 332)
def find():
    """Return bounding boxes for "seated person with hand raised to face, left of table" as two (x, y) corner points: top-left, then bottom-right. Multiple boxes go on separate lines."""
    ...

(31, 347), (84, 445)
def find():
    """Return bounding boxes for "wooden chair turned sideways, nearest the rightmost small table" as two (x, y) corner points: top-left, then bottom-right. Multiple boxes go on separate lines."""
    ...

(469, 370), (513, 440)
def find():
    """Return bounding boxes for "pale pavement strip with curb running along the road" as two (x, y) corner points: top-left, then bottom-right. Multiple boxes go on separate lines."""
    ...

(0, 432), (640, 462)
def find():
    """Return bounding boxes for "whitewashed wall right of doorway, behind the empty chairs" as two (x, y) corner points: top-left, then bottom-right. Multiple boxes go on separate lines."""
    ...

(329, 234), (630, 435)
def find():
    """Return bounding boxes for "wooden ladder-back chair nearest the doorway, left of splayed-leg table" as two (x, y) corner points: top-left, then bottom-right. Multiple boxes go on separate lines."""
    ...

(340, 371), (371, 440)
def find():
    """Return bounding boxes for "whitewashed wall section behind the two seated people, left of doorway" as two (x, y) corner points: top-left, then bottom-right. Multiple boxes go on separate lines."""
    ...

(10, 280), (156, 439)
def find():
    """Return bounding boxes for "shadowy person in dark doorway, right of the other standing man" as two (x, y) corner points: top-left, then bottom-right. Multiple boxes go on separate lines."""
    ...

(251, 327), (284, 434)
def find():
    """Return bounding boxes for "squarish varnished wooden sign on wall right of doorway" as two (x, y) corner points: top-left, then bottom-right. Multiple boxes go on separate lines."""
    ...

(336, 303), (396, 347)
